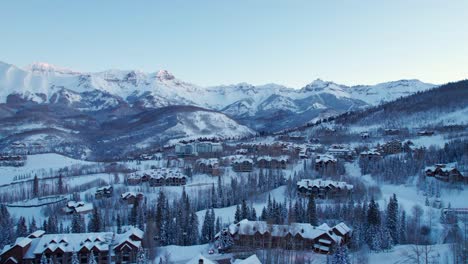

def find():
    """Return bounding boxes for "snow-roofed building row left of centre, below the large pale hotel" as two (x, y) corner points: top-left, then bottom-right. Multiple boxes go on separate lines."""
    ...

(127, 168), (187, 187)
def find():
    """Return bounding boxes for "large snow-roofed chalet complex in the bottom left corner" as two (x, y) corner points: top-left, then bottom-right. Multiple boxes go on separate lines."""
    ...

(0, 228), (143, 264)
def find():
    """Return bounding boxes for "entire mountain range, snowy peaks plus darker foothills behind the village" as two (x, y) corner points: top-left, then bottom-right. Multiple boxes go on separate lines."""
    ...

(0, 62), (437, 156)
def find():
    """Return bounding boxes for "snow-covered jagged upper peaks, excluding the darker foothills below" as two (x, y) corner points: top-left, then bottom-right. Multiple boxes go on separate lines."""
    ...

(0, 62), (435, 131)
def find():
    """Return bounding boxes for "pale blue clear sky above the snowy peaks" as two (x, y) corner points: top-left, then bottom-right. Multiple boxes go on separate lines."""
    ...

(0, 0), (468, 87)
